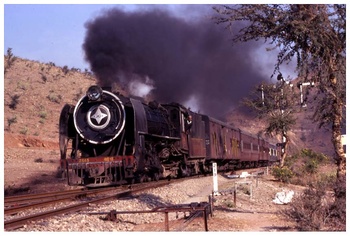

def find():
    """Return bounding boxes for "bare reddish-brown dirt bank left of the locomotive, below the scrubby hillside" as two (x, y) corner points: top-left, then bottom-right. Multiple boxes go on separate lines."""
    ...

(4, 132), (66, 196)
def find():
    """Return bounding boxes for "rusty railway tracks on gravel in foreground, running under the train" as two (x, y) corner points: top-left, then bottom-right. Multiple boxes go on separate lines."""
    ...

(4, 170), (266, 230)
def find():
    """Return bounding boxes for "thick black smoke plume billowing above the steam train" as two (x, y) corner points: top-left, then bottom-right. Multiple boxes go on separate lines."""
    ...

(83, 5), (263, 118)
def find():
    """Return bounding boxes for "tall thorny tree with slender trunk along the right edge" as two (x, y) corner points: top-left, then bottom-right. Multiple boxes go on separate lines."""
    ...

(214, 4), (346, 197)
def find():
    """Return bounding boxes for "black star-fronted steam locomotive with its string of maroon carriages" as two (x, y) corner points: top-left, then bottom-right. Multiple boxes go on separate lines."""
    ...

(59, 85), (279, 186)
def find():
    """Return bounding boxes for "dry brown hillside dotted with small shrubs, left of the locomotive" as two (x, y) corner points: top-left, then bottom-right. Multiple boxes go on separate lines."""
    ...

(4, 57), (95, 141)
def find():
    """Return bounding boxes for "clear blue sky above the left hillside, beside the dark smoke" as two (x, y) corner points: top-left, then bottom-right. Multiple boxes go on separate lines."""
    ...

(3, 0), (298, 73)
